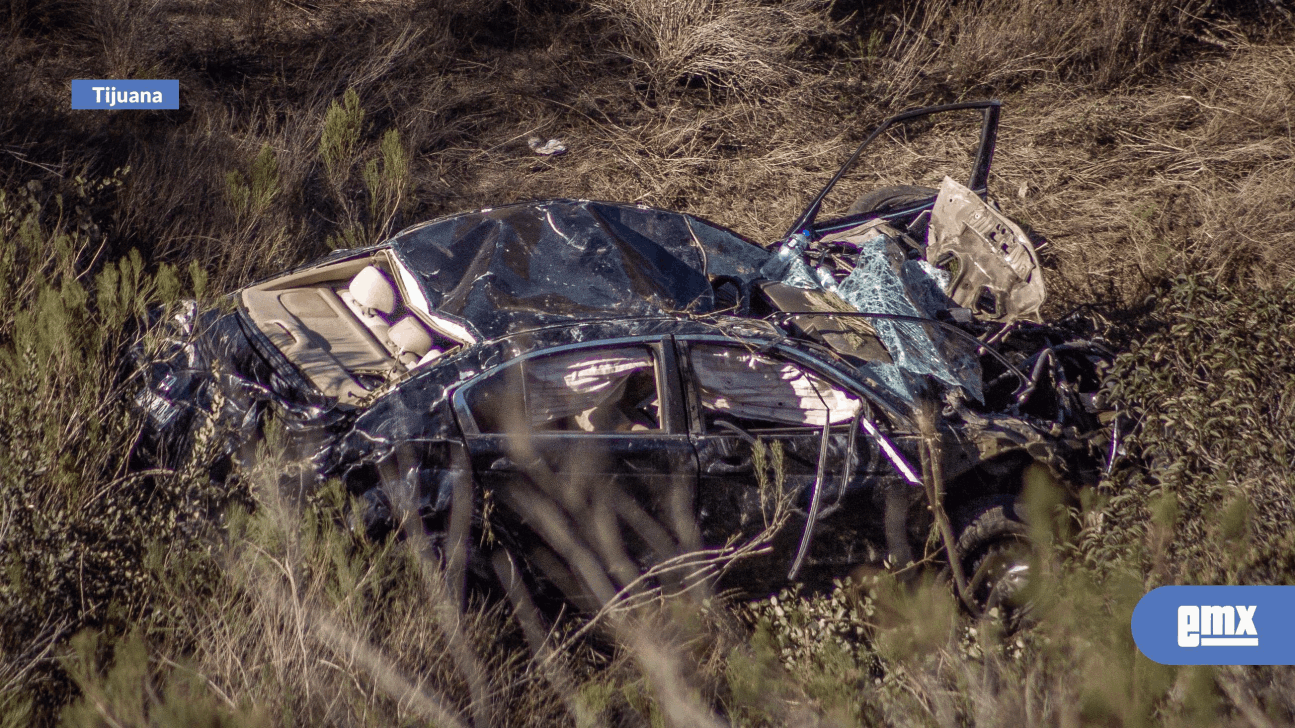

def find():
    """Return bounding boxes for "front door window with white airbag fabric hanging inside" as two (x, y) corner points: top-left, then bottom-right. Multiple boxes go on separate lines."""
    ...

(689, 343), (860, 433)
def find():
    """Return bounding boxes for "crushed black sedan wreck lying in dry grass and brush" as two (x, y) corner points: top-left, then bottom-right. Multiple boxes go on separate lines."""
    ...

(139, 101), (1110, 611)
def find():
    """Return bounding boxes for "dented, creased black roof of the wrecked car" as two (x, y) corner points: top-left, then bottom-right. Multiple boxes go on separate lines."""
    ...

(391, 195), (769, 339)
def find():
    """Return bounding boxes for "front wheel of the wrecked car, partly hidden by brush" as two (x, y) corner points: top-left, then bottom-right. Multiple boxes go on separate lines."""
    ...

(957, 497), (1033, 627)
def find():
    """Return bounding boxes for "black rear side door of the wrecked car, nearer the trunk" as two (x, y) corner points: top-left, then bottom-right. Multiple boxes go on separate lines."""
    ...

(455, 337), (699, 609)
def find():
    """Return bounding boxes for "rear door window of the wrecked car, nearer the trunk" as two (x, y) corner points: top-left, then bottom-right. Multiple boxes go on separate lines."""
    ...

(465, 346), (660, 434)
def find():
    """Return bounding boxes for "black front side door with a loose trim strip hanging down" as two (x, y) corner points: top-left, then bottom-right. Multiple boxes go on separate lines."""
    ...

(677, 337), (887, 574)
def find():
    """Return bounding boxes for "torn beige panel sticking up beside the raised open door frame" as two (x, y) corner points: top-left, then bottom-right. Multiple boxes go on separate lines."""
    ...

(926, 177), (1046, 324)
